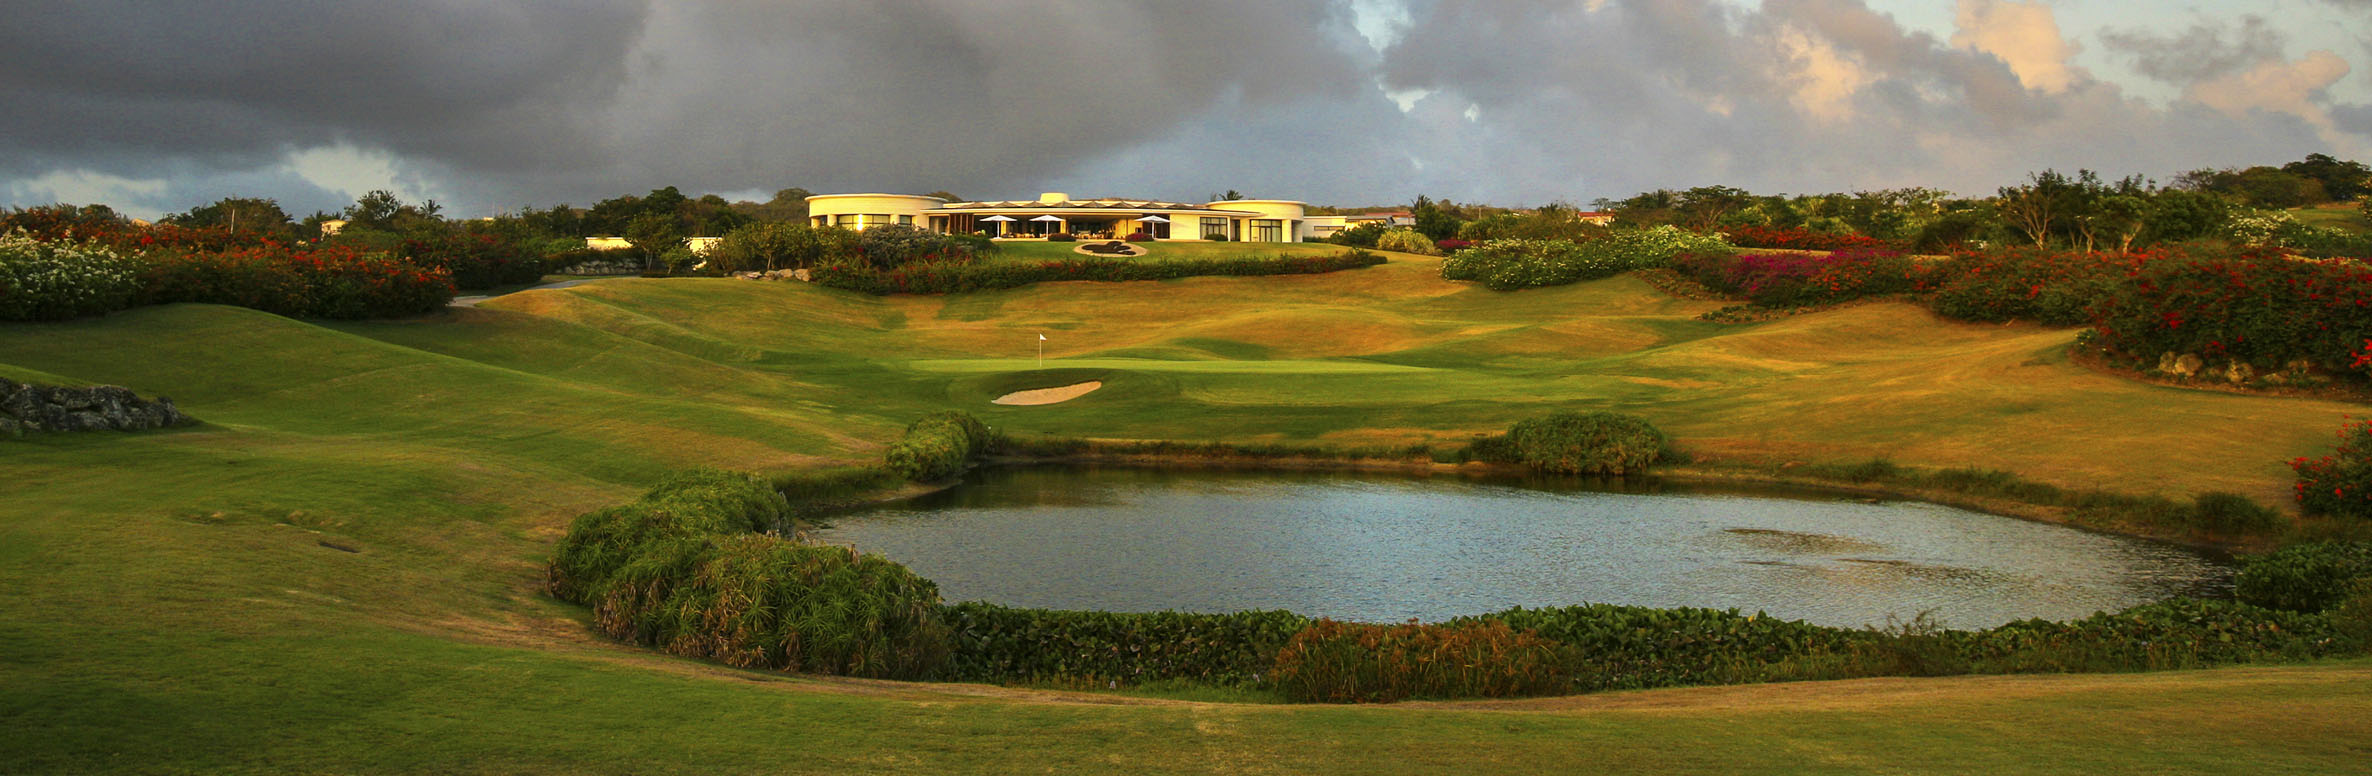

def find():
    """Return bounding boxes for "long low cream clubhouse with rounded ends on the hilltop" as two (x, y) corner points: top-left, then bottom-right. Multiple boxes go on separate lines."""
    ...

(806, 192), (1343, 242)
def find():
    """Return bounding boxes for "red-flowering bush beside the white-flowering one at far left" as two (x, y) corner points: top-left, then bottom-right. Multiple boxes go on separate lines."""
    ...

(140, 244), (453, 318)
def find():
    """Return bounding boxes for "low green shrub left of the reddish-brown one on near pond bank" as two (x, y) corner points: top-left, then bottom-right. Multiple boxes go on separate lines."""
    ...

(944, 603), (1309, 686)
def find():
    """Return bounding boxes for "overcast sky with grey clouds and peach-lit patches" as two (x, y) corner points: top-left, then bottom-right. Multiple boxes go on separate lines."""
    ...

(0, 0), (2372, 216)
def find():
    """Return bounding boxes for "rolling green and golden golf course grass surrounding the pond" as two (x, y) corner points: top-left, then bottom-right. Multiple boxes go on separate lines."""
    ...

(0, 259), (2372, 774)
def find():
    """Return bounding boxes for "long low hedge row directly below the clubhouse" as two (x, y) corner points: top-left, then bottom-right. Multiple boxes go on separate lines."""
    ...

(811, 249), (1383, 294)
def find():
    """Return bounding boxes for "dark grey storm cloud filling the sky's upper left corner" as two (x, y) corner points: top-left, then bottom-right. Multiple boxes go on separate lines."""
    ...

(0, 0), (645, 176)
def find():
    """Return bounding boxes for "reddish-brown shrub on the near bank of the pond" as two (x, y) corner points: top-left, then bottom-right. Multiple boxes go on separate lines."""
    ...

(1276, 619), (1568, 702)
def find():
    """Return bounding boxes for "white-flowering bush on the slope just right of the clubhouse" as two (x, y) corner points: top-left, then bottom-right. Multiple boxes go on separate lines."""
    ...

(1442, 225), (1729, 292)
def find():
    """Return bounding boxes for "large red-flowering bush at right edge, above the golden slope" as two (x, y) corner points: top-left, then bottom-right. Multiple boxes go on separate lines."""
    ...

(2094, 252), (2372, 375)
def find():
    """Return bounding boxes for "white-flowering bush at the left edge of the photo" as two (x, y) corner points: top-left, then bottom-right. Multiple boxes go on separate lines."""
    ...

(0, 230), (140, 320)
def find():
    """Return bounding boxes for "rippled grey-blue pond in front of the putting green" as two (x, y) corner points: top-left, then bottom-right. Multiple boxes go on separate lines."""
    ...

(816, 467), (2232, 629)
